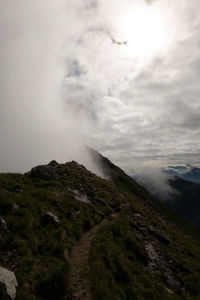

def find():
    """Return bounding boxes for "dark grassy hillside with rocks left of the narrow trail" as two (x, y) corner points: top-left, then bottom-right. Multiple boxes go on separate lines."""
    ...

(0, 162), (123, 300)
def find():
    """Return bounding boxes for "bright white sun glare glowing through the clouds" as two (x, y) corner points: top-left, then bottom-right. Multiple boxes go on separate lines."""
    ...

(121, 6), (167, 58)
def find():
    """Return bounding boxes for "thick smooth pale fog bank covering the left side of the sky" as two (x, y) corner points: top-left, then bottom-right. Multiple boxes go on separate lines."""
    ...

(0, 0), (97, 172)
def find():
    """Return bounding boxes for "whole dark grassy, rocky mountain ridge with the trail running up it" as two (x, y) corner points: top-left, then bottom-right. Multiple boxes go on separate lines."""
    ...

(0, 149), (200, 300)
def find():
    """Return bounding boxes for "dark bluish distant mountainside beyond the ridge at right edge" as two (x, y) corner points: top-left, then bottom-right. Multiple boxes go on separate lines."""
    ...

(167, 176), (200, 227)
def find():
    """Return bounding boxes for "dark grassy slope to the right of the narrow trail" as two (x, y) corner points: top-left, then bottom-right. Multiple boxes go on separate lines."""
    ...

(90, 197), (200, 300)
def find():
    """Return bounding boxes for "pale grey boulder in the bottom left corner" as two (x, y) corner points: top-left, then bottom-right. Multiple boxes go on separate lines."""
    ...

(0, 267), (18, 300)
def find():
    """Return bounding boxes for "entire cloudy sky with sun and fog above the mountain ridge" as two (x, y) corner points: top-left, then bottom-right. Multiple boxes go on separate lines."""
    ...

(0, 0), (200, 178)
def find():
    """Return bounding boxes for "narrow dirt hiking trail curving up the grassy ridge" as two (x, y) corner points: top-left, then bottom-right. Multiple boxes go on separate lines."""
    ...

(70, 214), (119, 300)
